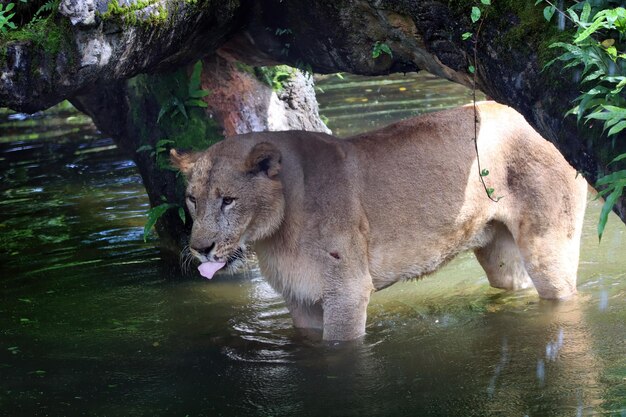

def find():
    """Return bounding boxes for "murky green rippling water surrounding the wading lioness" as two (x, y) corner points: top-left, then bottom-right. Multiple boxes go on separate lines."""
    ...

(0, 76), (626, 416)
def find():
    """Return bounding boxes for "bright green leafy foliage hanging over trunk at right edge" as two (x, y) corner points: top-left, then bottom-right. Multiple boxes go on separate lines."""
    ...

(535, 0), (626, 239)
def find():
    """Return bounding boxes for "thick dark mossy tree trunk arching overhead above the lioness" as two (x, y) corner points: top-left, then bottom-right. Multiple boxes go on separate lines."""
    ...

(0, 0), (626, 221)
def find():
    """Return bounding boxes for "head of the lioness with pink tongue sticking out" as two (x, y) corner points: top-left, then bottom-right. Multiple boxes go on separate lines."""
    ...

(171, 139), (285, 278)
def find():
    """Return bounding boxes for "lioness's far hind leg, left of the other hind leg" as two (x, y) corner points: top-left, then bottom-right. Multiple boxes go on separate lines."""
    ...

(474, 222), (533, 290)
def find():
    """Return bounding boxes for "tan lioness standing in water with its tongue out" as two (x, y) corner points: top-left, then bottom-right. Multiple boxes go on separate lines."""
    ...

(171, 102), (587, 340)
